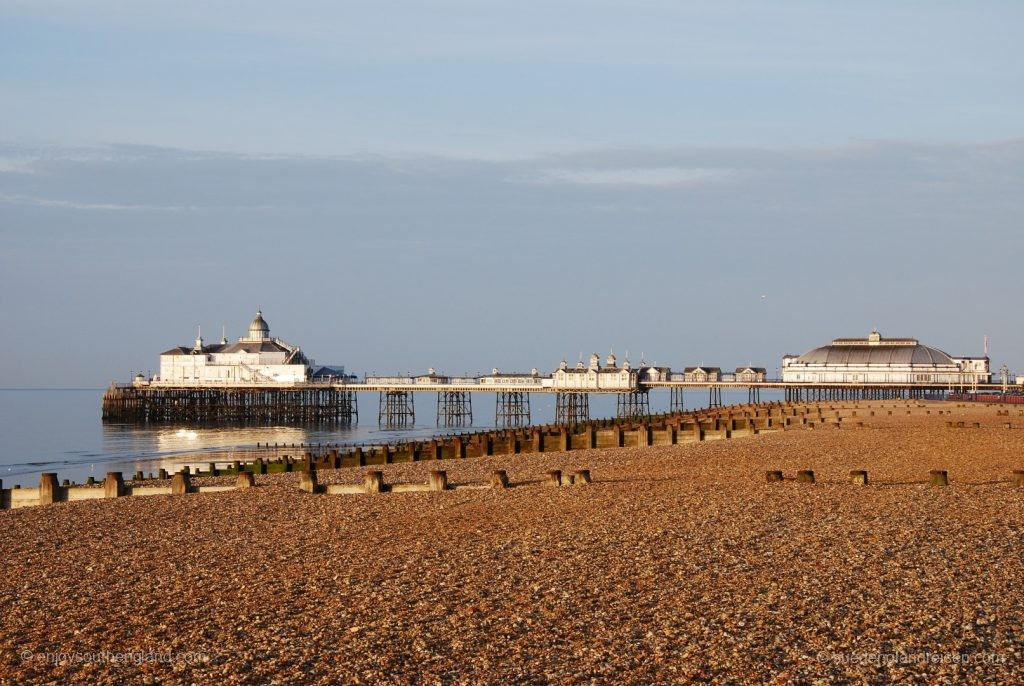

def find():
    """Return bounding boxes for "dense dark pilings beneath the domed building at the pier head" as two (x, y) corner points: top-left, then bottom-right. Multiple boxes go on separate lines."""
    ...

(103, 384), (358, 423)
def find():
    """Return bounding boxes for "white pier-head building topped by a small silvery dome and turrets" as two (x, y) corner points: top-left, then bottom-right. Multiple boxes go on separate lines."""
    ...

(151, 311), (310, 386)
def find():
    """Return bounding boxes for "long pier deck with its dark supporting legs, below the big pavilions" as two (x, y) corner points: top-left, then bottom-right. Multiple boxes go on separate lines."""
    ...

(102, 372), (1006, 428)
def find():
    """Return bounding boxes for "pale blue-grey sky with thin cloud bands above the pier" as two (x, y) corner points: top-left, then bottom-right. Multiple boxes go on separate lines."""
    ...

(0, 0), (1024, 387)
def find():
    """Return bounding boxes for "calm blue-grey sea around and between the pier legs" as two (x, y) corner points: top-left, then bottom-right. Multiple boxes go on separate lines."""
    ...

(0, 389), (778, 488)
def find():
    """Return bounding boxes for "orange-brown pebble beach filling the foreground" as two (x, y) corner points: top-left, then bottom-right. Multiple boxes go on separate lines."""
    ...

(0, 401), (1024, 684)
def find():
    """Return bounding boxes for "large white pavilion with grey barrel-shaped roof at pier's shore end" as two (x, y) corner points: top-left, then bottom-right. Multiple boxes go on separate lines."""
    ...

(782, 331), (992, 386)
